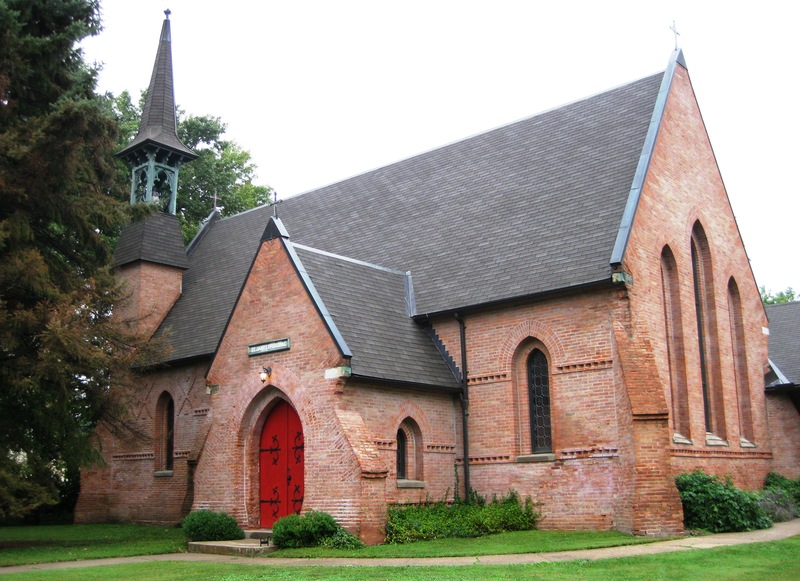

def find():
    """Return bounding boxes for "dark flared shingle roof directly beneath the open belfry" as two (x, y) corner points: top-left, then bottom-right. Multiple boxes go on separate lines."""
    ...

(112, 213), (189, 268)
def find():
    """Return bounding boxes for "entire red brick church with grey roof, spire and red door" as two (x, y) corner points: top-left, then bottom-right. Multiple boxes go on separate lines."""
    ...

(76, 13), (800, 542)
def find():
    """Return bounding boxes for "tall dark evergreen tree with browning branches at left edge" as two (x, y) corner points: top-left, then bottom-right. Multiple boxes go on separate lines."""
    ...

(0, 0), (156, 517)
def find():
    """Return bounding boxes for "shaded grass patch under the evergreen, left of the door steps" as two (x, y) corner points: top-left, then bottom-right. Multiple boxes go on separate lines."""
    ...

(0, 525), (186, 567)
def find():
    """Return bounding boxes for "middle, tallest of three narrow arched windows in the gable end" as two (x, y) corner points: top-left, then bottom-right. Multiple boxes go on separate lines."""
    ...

(691, 222), (725, 443)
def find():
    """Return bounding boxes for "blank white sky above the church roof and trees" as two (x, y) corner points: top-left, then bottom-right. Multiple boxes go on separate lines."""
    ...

(84, 0), (800, 291)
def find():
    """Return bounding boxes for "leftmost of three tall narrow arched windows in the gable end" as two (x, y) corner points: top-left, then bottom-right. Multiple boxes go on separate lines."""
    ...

(661, 246), (691, 444)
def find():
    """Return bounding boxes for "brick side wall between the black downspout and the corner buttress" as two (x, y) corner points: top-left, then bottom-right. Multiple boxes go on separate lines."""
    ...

(434, 286), (644, 530)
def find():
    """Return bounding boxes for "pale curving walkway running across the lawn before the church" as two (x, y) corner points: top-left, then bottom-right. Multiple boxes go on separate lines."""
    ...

(0, 519), (800, 575)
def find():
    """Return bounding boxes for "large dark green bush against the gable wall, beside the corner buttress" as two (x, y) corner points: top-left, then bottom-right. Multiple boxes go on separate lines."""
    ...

(675, 470), (772, 533)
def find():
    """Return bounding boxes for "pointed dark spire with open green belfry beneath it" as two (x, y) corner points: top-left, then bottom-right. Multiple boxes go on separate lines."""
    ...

(117, 10), (197, 215)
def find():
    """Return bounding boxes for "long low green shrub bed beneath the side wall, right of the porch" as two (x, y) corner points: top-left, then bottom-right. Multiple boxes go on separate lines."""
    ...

(386, 491), (539, 544)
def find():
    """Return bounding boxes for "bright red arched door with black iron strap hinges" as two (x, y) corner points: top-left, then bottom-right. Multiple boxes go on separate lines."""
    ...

(259, 401), (304, 528)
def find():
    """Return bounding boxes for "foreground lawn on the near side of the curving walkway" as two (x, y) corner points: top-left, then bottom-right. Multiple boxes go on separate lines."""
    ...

(4, 537), (800, 581)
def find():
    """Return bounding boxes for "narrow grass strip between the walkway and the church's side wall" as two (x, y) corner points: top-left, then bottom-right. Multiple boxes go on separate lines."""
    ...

(269, 531), (665, 559)
